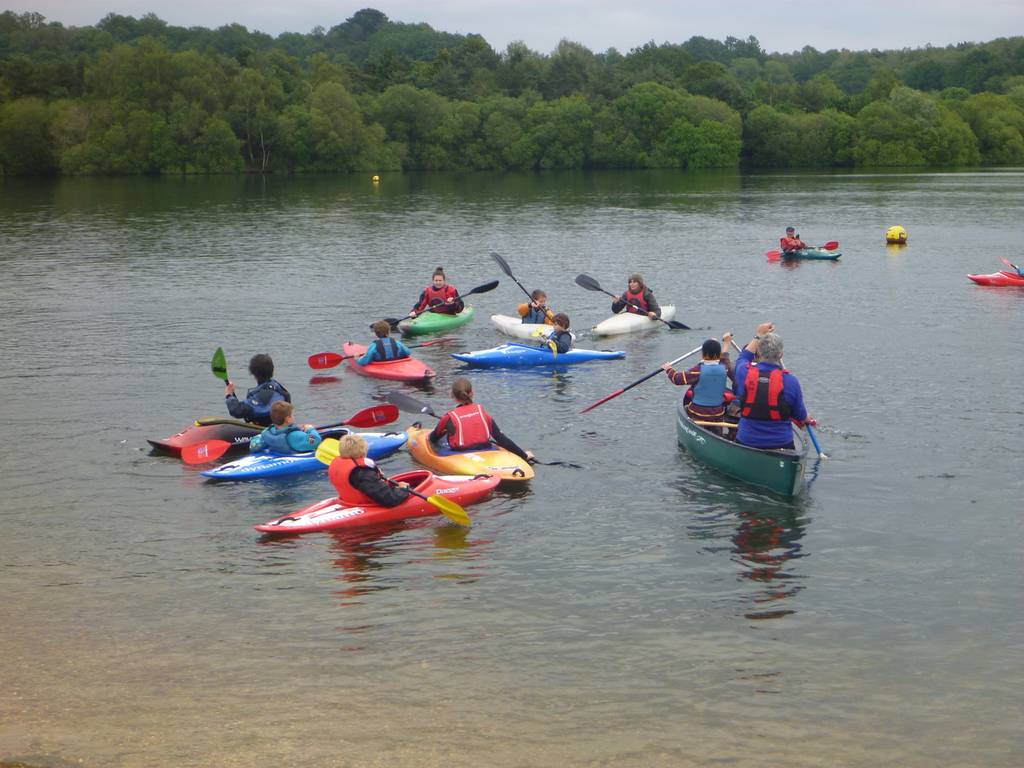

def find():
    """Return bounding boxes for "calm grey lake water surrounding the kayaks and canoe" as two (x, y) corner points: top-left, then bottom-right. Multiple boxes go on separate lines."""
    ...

(0, 171), (1024, 768)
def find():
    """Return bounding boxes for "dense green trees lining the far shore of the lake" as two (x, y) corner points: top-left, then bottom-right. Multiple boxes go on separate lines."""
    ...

(0, 9), (1024, 174)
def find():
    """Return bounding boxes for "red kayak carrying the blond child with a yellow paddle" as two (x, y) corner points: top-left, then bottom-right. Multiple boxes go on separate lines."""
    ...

(255, 469), (501, 534)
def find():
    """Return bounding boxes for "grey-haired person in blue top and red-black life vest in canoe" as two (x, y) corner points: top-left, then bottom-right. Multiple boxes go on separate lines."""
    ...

(735, 323), (813, 449)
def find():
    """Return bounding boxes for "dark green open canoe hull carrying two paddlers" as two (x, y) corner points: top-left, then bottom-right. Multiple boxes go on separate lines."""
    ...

(676, 403), (808, 497)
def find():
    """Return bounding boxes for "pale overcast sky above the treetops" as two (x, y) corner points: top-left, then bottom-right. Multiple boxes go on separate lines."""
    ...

(5, 0), (1024, 53)
